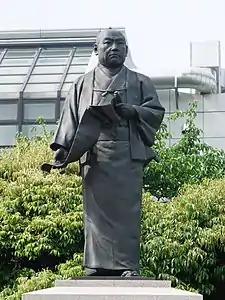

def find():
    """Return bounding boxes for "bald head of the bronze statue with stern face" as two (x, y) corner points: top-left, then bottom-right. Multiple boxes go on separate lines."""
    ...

(94, 29), (128, 69)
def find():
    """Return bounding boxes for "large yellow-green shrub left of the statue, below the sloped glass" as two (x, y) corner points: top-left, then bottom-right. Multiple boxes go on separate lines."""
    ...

(0, 124), (83, 289)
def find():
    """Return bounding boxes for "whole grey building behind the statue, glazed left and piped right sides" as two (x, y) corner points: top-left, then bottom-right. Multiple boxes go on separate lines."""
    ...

(0, 28), (225, 149)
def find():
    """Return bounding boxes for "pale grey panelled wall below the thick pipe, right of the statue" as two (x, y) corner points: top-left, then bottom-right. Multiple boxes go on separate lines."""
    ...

(158, 90), (225, 149)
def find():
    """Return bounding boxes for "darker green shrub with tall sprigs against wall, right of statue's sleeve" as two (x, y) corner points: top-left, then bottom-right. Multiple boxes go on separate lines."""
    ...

(144, 102), (225, 198)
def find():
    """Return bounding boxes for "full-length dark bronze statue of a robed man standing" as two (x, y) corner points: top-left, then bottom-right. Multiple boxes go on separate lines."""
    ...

(43, 29), (165, 276)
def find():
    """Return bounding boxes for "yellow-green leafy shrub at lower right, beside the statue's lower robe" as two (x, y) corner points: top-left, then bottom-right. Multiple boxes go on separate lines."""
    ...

(141, 179), (225, 295)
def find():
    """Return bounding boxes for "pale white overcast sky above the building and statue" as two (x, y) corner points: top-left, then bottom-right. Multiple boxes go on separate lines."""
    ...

(0, 0), (225, 76)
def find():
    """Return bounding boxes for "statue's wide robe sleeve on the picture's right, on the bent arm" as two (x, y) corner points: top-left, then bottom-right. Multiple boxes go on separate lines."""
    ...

(133, 77), (165, 147)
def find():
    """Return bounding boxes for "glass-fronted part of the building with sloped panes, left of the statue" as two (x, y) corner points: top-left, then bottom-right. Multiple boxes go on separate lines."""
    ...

(0, 30), (104, 146)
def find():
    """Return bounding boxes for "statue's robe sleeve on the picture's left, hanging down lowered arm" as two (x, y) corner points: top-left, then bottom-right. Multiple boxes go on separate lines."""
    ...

(50, 83), (78, 151)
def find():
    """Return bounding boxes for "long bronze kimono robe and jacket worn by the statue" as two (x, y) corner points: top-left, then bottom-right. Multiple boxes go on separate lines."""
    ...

(51, 66), (165, 271)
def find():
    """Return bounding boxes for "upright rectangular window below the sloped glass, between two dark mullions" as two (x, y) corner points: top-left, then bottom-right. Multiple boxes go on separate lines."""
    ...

(24, 102), (55, 120)
